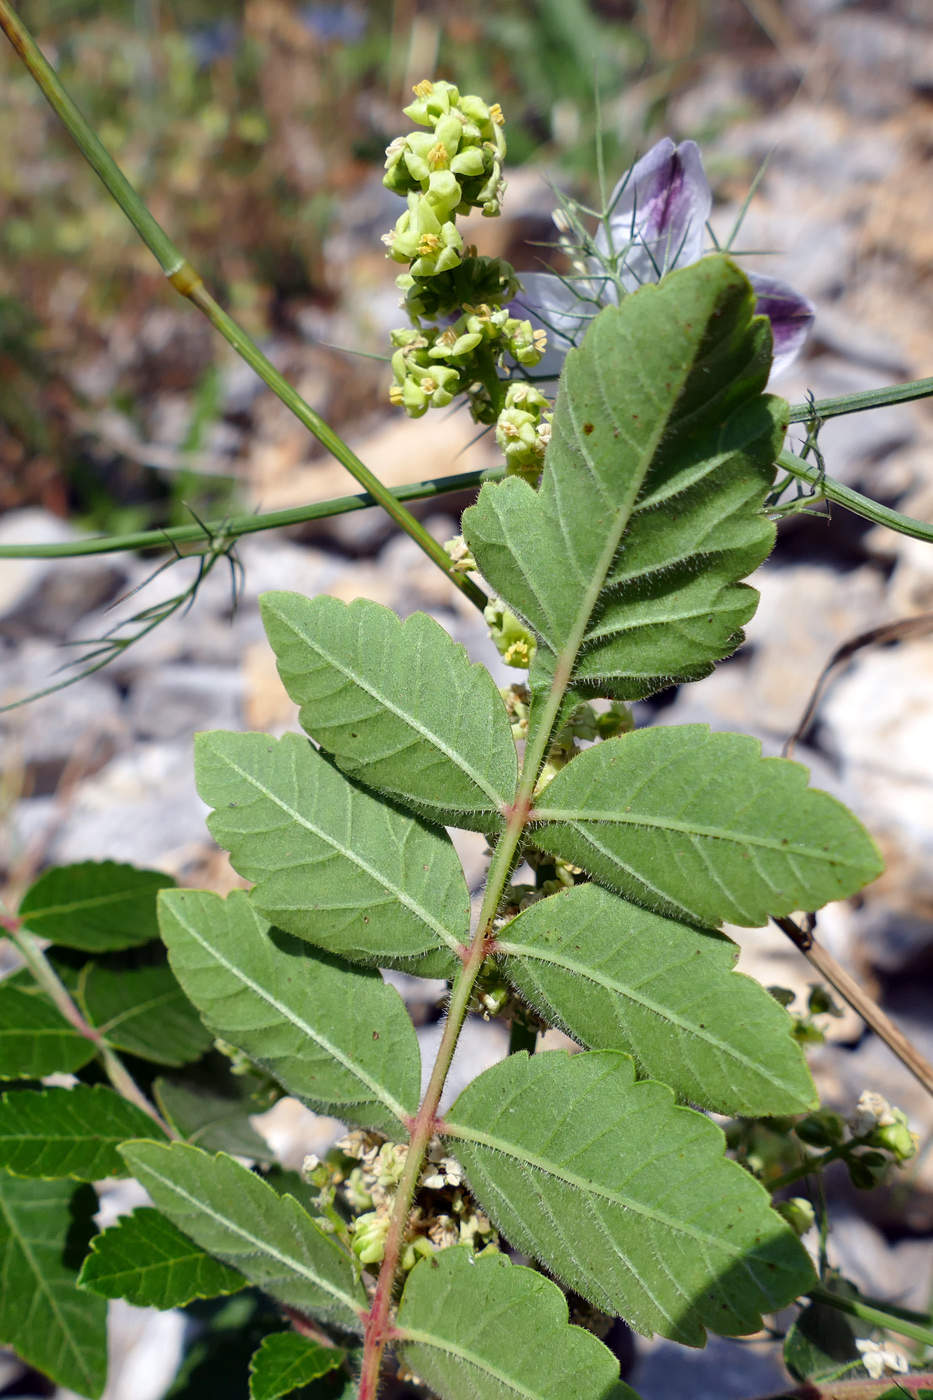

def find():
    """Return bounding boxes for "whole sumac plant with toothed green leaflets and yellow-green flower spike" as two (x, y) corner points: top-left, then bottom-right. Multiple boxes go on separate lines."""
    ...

(0, 65), (913, 1400)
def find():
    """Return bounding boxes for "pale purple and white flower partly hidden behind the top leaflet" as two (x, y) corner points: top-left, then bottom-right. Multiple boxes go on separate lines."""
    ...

(513, 136), (815, 378)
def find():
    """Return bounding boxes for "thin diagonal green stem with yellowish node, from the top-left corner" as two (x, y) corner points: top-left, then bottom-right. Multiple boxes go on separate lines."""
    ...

(0, 0), (488, 610)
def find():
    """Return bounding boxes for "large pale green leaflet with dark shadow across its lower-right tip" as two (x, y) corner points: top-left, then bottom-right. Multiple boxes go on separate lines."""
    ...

(444, 1050), (814, 1347)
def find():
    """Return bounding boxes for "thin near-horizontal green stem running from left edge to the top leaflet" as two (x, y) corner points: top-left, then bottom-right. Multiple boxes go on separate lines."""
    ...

(0, 468), (506, 559)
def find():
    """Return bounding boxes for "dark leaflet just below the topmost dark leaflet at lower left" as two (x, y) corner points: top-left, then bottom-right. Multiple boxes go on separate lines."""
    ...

(77, 952), (213, 1065)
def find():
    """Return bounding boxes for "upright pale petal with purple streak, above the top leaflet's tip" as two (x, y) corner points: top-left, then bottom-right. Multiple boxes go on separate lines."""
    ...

(595, 136), (713, 290)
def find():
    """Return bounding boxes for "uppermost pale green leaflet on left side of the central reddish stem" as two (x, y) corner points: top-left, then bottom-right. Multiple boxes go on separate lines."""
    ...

(262, 594), (518, 832)
